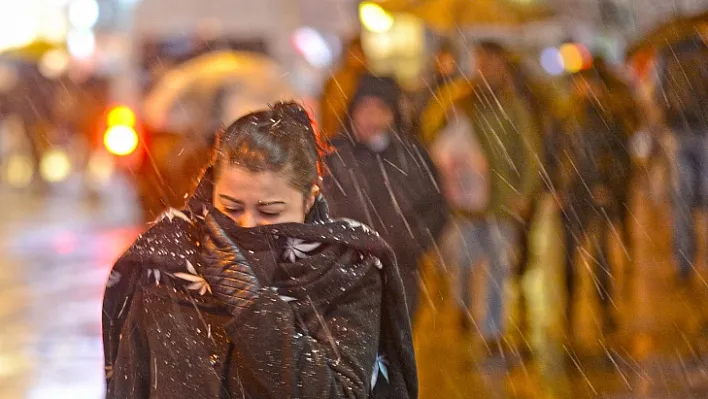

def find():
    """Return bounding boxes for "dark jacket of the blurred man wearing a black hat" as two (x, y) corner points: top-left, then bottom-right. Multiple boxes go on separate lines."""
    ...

(324, 133), (447, 309)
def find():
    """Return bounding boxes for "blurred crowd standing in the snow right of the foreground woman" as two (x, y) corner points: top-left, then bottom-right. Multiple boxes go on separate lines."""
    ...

(319, 32), (708, 356)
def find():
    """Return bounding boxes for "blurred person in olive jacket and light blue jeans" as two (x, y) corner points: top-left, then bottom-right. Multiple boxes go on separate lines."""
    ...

(431, 42), (543, 349)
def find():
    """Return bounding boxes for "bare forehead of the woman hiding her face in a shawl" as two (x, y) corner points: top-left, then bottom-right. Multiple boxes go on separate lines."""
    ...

(216, 166), (302, 202)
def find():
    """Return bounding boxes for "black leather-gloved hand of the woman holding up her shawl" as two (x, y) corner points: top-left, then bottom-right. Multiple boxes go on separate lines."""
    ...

(203, 215), (261, 315)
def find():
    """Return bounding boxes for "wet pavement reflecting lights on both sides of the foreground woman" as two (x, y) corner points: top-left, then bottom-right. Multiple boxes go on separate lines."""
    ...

(0, 177), (708, 399)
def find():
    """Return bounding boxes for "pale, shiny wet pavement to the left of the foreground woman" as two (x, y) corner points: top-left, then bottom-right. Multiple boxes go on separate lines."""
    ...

(0, 180), (137, 399)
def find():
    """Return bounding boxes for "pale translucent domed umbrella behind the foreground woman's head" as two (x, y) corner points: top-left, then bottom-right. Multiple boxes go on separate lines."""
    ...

(144, 51), (293, 129)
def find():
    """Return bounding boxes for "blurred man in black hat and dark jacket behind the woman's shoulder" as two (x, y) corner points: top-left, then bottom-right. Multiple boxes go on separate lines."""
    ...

(324, 75), (447, 315)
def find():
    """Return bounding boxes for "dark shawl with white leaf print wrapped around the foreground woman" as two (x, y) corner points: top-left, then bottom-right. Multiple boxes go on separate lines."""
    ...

(103, 170), (417, 399)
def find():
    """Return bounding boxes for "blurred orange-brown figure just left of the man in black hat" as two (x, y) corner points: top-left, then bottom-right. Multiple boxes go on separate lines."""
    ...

(319, 38), (367, 137)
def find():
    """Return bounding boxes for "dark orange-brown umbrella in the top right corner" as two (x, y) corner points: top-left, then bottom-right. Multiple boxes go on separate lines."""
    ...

(627, 12), (708, 58)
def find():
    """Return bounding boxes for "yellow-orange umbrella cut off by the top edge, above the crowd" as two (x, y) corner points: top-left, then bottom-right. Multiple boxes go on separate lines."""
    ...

(376, 0), (553, 32)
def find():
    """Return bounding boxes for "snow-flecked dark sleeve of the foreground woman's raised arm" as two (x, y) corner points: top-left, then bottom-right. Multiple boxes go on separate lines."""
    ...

(226, 267), (382, 398)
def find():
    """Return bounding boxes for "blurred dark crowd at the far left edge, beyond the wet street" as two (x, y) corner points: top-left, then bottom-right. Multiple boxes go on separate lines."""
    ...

(0, 59), (109, 193)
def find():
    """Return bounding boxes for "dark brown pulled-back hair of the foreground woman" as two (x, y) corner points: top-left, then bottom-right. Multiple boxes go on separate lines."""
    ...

(212, 102), (328, 194)
